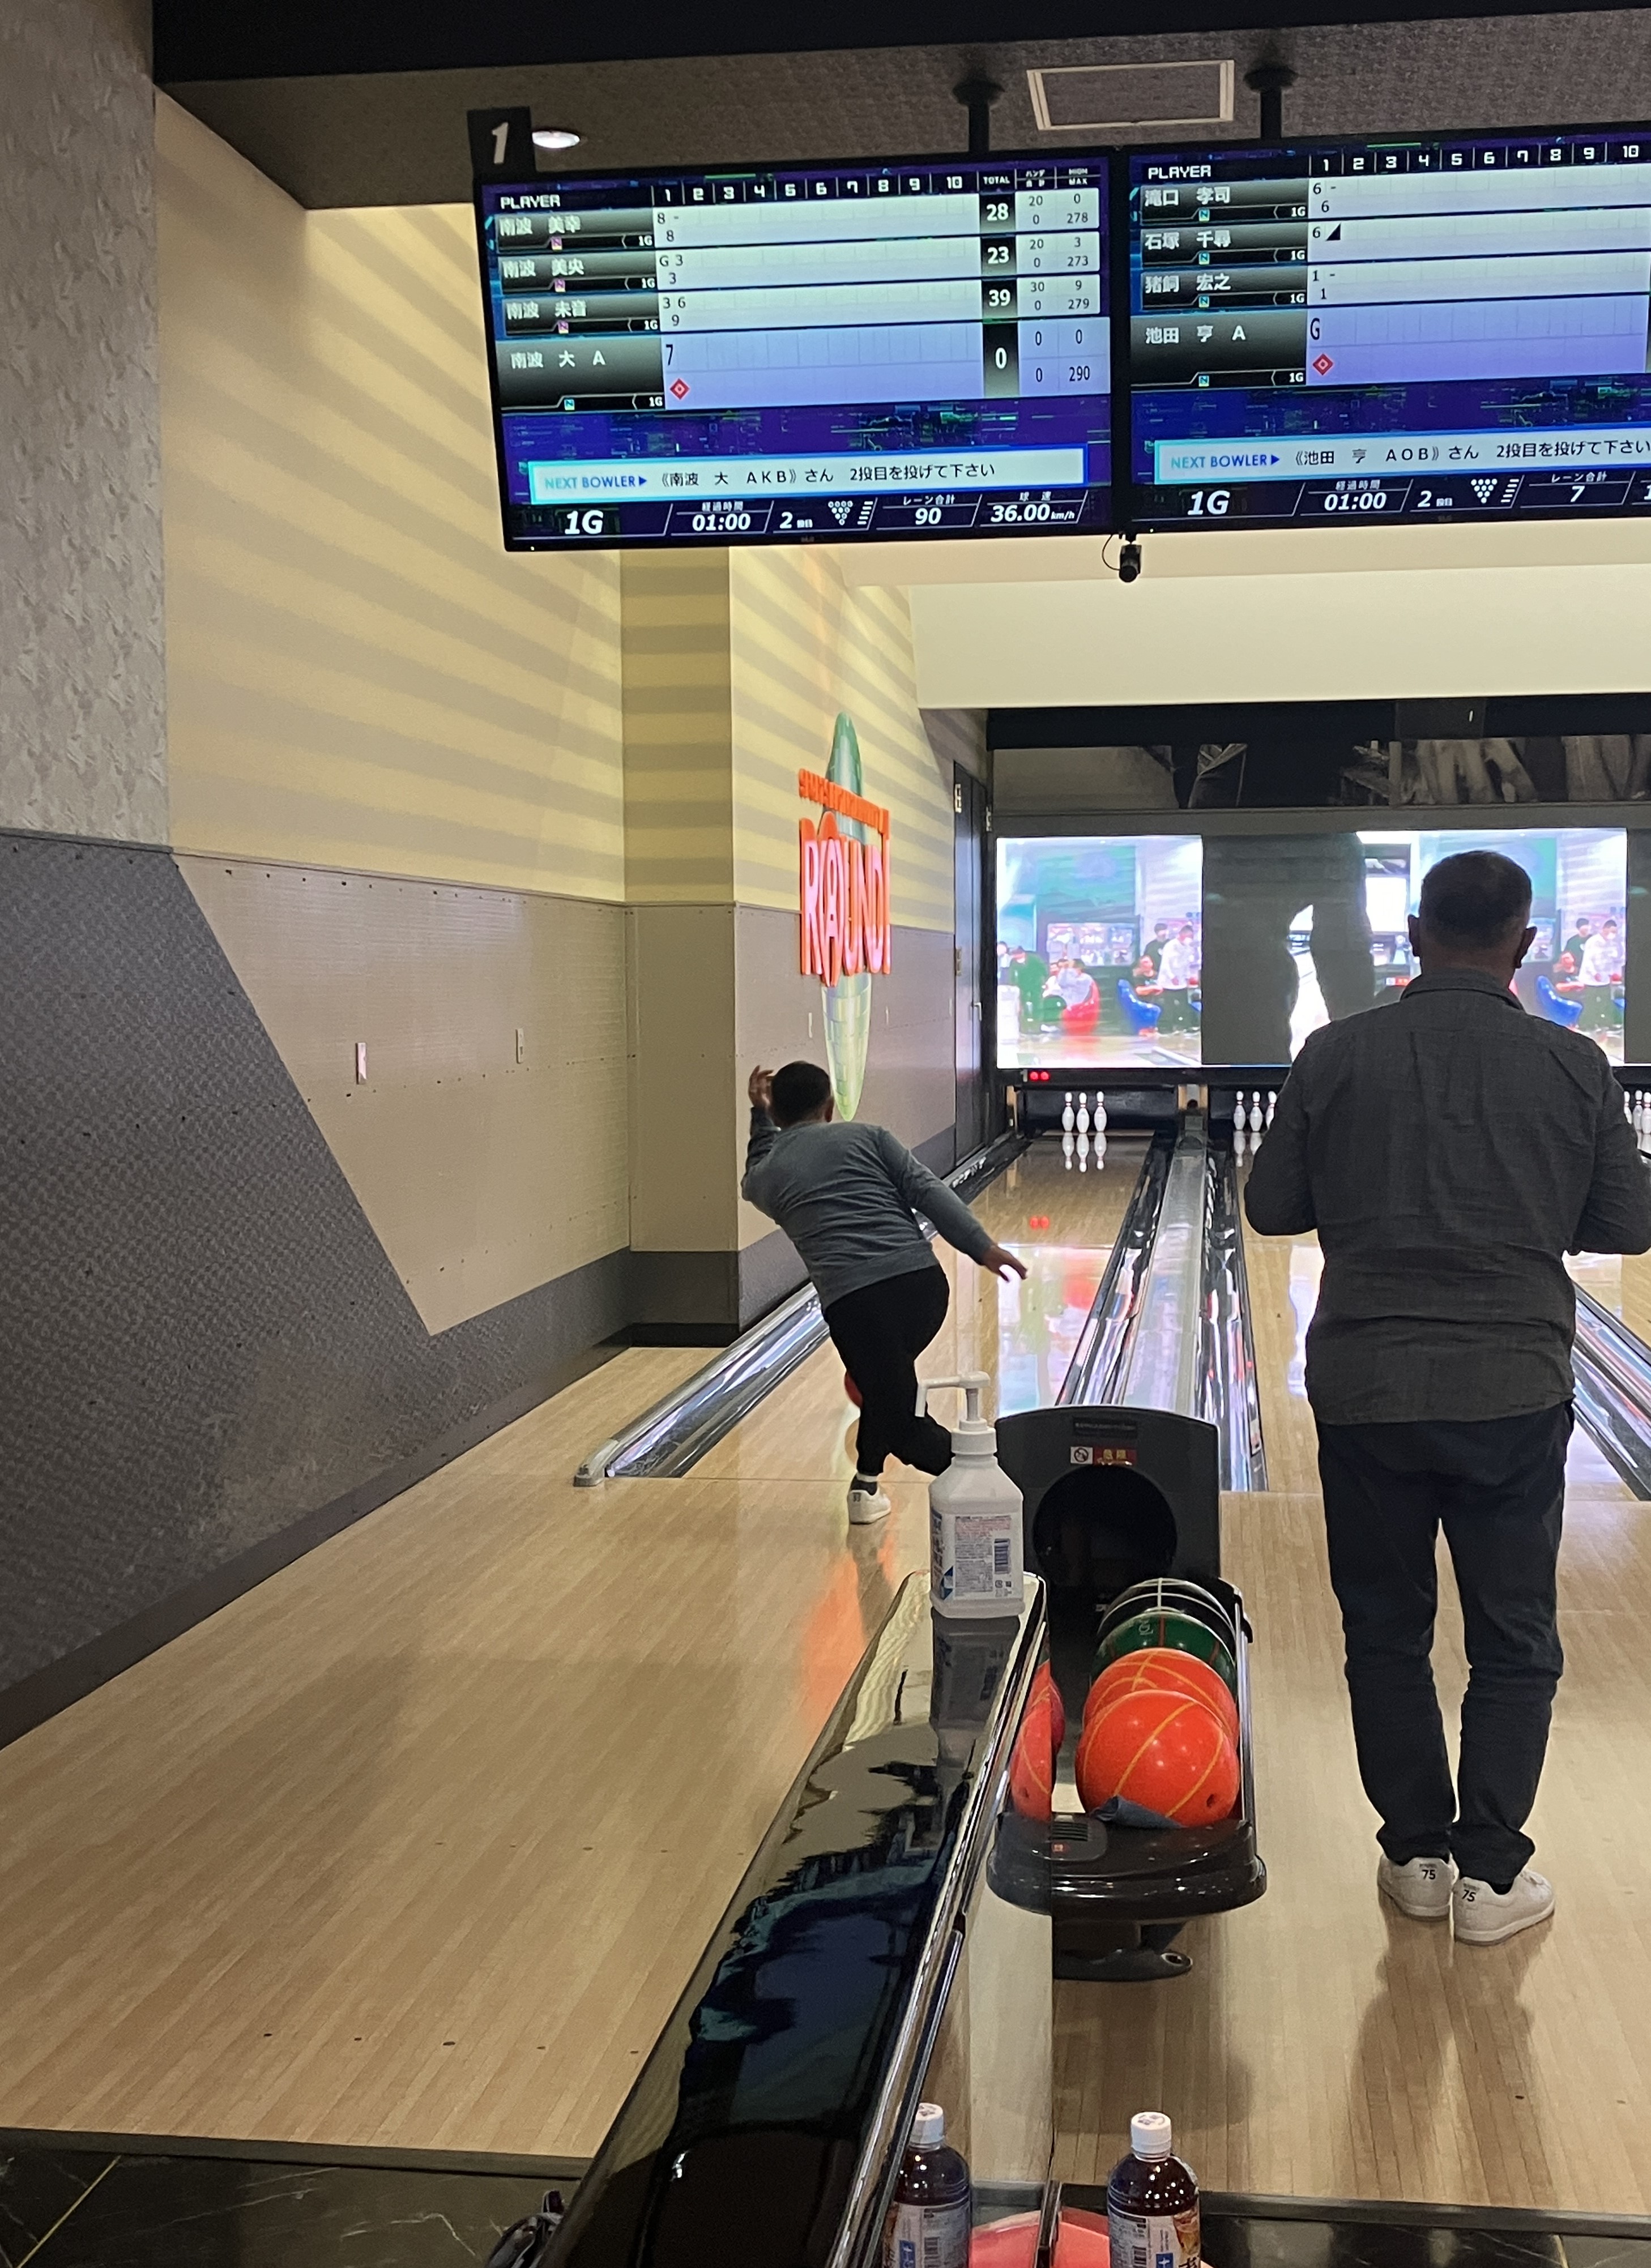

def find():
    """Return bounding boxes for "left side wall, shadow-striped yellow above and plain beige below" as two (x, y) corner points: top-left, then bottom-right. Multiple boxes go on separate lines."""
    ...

(156, 110), (630, 1331)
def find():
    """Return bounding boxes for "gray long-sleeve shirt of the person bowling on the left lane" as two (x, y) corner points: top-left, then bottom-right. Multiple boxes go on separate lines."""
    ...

(739, 1109), (991, 1306)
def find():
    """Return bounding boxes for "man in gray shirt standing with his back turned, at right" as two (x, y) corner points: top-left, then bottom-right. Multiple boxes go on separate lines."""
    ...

(1245, 851), (1651, 1944)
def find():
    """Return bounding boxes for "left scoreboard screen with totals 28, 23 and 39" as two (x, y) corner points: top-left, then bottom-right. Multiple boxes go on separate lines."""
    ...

(476, 154), (1111, 549)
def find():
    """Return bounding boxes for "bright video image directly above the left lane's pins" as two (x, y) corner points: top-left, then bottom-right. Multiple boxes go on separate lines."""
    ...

(998, 835), (1204, 1070)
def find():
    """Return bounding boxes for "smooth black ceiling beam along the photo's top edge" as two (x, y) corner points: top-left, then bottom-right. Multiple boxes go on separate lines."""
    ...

(154, 0), (1651, 86)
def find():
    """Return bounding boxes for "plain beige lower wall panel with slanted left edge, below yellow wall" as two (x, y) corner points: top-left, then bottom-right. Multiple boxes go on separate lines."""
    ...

(179, 857), (628, 1331)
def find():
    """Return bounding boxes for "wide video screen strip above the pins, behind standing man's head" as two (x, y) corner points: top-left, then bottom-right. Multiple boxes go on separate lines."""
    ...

(998, 826), (1628, 1073)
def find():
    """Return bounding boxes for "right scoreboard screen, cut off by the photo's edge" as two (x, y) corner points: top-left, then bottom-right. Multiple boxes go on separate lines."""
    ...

(1120, 127), (1651, 528)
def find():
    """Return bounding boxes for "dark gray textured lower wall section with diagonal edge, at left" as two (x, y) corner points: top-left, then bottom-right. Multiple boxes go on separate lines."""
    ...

(0, 835), (630, 1737)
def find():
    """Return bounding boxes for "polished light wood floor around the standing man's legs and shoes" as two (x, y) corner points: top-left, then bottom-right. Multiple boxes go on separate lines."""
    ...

(1057, 1234), (1651, 2214)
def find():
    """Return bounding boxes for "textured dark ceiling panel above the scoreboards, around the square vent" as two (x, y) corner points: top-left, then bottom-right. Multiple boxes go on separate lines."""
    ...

(170, 9), (1651, 206)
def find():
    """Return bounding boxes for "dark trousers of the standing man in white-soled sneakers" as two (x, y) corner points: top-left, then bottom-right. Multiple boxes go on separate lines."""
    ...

(1317, 1402), (1572, 1885)
